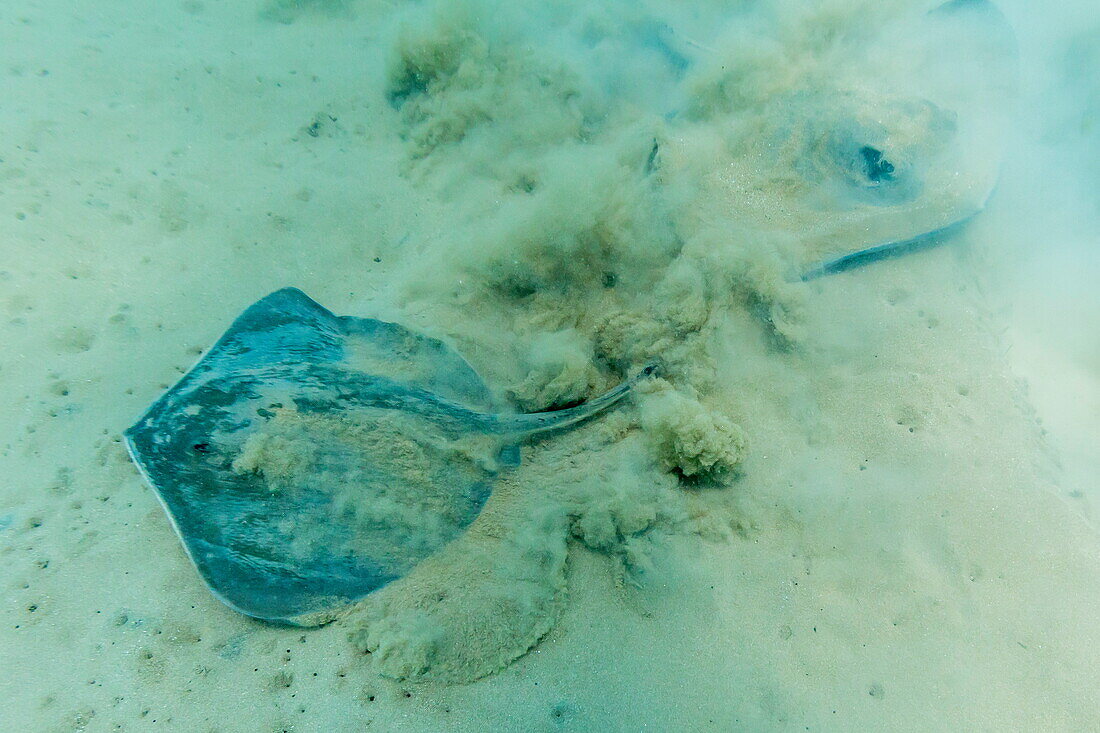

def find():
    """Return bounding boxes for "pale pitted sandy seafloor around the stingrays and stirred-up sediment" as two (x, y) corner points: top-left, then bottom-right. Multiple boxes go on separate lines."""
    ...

(0, 0), (1100, 732)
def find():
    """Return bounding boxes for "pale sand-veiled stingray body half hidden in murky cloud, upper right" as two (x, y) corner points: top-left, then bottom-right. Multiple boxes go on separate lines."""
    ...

(803, 0), (1019, 280)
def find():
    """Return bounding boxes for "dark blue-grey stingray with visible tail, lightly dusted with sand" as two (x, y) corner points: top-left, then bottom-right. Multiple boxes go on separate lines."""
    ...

(125, 288), (653, 626)
